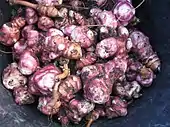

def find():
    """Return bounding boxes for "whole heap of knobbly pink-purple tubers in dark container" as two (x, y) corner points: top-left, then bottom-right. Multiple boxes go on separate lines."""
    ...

(0, 0), (161, 127)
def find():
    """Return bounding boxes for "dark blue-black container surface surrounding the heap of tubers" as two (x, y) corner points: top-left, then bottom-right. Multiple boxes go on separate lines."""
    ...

(0, 0), (170, 127)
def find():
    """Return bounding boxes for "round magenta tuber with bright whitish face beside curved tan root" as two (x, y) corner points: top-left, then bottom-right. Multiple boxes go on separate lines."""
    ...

(31, 64), (61, 95)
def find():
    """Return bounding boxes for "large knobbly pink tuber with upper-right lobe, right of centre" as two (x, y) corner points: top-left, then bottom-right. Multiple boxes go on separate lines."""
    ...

(81, 58), (127, 104)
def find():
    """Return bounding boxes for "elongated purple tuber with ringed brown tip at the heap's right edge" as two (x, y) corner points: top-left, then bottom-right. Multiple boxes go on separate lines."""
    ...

(129, 30), (161, 72)
